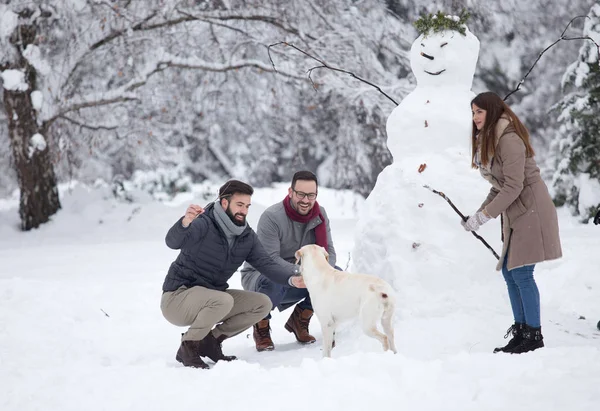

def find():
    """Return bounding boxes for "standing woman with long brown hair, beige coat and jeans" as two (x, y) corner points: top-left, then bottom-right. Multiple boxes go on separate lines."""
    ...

(462, 92), (562, 354)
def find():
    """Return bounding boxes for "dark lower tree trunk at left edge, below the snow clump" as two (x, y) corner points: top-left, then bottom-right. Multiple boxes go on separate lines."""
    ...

(4, 86), (60, 231)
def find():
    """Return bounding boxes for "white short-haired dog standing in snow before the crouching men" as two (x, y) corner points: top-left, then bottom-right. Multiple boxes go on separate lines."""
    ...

(296, 244), (396, 357)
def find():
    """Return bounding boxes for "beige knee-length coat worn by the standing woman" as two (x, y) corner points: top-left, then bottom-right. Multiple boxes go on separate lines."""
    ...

(479, 117), (562, 270)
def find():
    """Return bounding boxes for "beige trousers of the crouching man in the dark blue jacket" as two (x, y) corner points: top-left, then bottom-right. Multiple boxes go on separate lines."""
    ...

(160, 286), (272, 341)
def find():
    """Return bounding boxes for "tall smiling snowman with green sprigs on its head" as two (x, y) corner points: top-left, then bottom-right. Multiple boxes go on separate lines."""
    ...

(352, 13), (499, 316)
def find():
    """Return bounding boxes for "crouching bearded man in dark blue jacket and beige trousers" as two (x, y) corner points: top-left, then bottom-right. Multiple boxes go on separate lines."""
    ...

(160, 180), (306, 368)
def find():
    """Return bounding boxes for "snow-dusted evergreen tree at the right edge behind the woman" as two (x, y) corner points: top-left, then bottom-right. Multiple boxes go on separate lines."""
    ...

(551, 4), (600, 221)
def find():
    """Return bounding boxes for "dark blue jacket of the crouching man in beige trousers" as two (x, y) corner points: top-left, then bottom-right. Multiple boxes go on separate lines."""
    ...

(163, 204), (294, 292)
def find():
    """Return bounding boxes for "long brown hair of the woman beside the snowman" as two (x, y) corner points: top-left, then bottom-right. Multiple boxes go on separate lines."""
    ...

(471, 91), (535, 168)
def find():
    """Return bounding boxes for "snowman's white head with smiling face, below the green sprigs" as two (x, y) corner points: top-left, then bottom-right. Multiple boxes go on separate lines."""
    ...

(410, 27), (479, 90)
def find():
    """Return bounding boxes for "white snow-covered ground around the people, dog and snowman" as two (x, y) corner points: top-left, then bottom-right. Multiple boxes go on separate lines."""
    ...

(0, 184), (600, 411)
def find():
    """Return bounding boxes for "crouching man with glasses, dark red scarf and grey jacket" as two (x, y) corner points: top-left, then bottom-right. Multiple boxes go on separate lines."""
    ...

(242, 171), (336, 351)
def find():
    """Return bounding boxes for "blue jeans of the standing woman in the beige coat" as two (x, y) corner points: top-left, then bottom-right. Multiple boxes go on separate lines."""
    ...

(502, 258), (540, 328)
